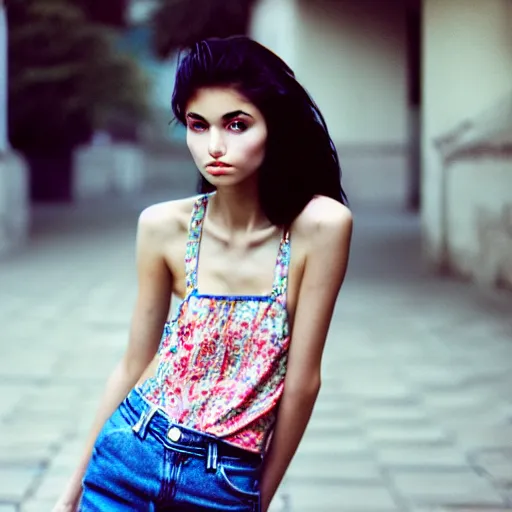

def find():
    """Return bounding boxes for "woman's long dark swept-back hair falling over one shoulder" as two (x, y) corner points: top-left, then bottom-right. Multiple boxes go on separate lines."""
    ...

(172, 36), (348, 226)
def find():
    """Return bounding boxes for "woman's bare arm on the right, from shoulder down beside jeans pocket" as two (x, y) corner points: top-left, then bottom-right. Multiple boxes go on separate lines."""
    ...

(261, 201), (352, 512)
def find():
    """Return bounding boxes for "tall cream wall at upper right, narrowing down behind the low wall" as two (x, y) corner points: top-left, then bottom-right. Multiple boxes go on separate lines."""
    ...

(422, 0), (512, 263)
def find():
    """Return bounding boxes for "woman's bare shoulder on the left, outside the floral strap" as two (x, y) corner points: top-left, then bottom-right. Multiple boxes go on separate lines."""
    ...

(138, 196), (202, 239)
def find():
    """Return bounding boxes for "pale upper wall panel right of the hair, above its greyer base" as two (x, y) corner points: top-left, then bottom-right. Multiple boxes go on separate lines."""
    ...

(296, 0), (407, 145)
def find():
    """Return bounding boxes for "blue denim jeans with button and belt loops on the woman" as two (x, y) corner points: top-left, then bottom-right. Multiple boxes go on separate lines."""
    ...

(82, 390), (262, 512)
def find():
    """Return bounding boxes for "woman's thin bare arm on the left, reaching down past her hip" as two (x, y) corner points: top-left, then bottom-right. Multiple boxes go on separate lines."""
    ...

(54, 207), (172, 512)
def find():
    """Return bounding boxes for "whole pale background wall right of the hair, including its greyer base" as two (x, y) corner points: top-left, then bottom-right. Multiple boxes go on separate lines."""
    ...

(251, 0), (408, 204)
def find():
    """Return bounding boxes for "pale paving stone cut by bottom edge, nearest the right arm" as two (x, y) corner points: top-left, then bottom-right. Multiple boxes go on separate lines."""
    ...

(288, 479), (398, 512)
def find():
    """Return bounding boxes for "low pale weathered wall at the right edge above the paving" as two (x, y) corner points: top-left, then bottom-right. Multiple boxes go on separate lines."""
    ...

(445, 157), (512, 289)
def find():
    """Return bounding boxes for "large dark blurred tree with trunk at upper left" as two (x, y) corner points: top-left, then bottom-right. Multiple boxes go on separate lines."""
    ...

(7, 0), (147, 200)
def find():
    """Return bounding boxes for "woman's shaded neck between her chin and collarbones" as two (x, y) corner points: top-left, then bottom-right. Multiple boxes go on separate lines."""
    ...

(208, 183), (270, 233)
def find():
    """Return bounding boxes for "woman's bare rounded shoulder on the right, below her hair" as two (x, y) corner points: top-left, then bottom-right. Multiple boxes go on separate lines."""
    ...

(294, 196), (353, 247)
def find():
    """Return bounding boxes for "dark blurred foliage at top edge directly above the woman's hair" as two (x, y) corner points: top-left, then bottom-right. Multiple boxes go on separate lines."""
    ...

(152, 0), (256, 58)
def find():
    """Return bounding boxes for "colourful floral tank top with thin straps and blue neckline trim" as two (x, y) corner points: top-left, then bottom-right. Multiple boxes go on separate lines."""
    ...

(139, 195), (290, 453)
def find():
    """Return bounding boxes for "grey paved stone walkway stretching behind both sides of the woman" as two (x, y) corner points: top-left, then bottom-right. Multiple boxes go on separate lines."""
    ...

(0, 192), (512, 512)
